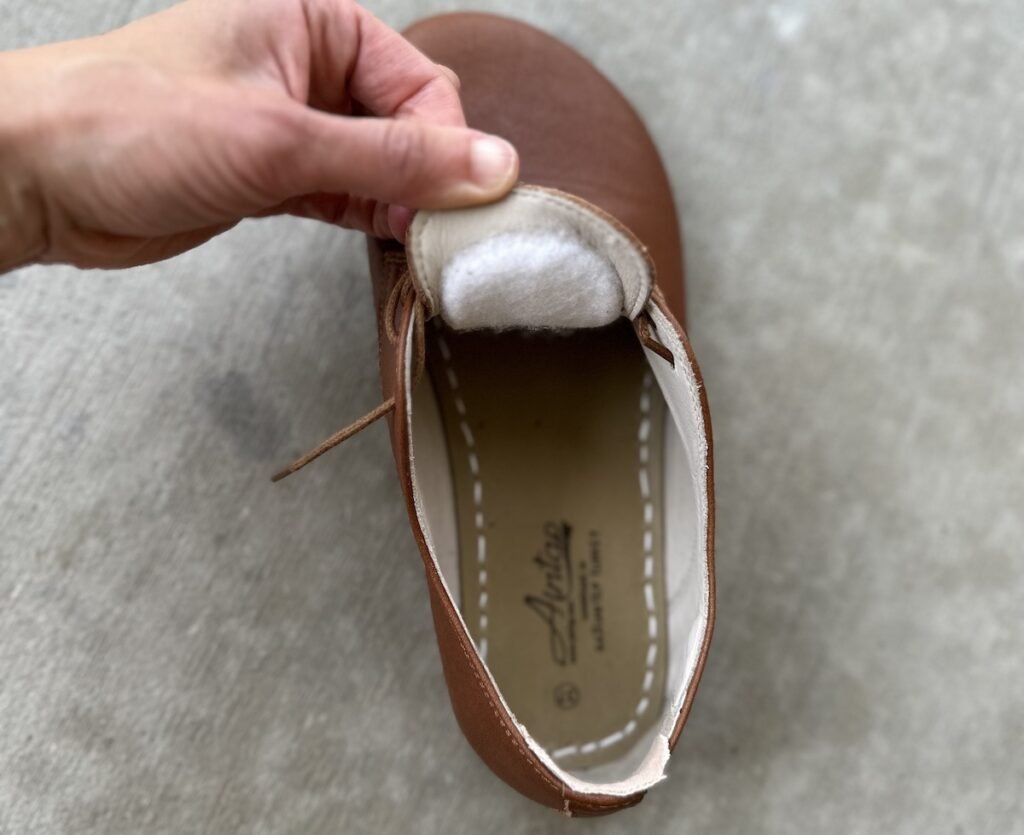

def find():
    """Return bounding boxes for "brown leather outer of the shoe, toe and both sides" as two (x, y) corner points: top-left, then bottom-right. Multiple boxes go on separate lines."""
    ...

(369, 14), (714, 816)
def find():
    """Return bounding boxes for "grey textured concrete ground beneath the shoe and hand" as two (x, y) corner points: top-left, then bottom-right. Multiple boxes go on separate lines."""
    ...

(0, 0), (1024, 835)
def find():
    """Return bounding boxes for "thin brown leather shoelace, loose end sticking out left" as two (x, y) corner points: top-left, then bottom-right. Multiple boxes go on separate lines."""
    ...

(270, 269), (676, 482)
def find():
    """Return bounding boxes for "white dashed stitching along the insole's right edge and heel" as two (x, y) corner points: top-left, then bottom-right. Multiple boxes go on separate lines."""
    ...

(551, 369), (657, 759)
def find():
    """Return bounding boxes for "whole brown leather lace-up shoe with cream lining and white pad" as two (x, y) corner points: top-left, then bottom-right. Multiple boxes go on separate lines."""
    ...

(280, 9), (714, 815)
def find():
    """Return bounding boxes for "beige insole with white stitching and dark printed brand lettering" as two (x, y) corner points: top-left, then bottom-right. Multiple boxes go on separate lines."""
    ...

(428, 320), (667, 769)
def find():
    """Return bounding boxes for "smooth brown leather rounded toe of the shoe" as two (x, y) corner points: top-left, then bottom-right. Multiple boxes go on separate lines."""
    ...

(404, 13), (686, 323)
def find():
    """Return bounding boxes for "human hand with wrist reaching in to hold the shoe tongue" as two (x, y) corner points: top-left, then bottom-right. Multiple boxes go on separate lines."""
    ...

(0, 0), (518, 272)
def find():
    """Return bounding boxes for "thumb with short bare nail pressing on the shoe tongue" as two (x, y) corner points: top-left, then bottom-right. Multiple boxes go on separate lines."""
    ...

(273, 109), (519, 209)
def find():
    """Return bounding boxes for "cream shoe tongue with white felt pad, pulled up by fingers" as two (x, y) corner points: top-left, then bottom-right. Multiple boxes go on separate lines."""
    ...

(406, 186), (654, 330)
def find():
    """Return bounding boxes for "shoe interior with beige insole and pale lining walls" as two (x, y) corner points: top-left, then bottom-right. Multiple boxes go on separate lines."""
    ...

(411, 319), (708, 784)
